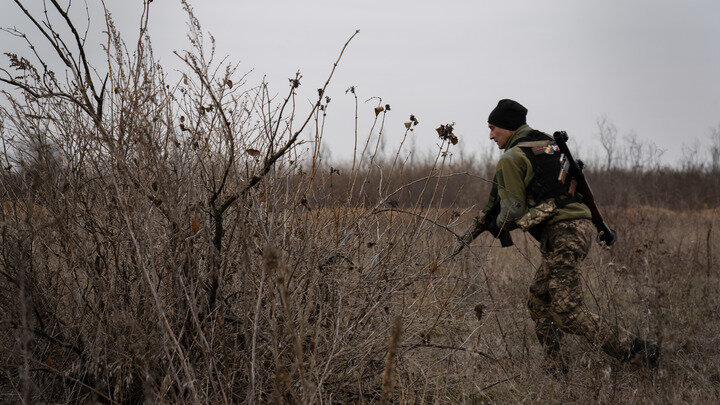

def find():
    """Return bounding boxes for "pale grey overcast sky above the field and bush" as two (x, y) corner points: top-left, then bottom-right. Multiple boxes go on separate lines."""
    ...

(0, 0), (720, 164)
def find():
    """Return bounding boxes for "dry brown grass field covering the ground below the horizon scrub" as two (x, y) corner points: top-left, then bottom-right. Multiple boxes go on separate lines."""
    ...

(0, 193), (720, 403)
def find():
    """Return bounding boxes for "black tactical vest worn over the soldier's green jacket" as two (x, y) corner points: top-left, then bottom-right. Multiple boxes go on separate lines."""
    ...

(510, 130), (582, 208)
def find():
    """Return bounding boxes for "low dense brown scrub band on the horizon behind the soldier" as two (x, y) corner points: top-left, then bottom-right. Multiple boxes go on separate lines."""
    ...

(296, 156), (720, 211)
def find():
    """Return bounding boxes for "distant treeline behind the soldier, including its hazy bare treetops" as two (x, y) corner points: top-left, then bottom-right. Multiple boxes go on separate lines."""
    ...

(300, 116), (720, 211)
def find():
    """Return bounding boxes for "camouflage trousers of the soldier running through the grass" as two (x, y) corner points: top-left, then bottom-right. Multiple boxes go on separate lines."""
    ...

(527, 219), (634, 362)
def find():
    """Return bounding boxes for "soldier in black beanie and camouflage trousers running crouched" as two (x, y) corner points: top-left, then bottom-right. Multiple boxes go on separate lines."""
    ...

(478, 99), (660, 374)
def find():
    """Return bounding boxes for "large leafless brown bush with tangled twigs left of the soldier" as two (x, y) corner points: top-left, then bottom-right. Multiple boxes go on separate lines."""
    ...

(0, 0), (478, 402)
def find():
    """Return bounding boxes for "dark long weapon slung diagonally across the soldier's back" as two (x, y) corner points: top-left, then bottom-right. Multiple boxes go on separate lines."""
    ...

(553, 131), (617, 246)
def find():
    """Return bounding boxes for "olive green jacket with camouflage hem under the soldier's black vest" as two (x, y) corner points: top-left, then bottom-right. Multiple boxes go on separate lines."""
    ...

(483, 125), (592, 230)
